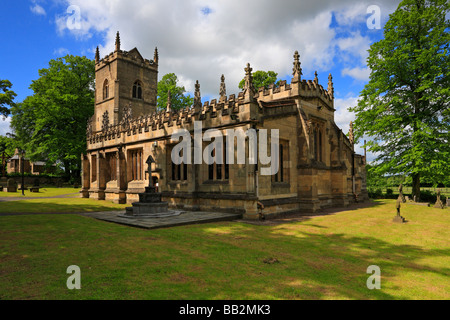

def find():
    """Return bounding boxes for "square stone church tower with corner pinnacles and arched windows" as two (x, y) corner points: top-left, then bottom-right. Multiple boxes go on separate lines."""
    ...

(92, 32), (158, 132)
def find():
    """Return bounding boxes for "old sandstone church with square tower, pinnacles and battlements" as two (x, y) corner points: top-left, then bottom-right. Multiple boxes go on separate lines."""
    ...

(81, 33), (368, 219)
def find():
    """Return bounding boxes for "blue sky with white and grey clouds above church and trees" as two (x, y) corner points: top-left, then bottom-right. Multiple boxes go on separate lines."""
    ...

(0, 0), (398, 160)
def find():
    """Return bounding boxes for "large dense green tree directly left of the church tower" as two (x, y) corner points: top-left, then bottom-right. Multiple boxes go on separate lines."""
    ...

(11, 55), (95, 178)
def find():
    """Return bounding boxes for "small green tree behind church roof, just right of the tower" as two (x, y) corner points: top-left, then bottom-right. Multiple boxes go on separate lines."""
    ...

(157, 73), (194, 110)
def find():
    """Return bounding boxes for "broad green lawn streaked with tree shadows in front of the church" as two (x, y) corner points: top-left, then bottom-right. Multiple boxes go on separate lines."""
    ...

(0, 199), (450, 299)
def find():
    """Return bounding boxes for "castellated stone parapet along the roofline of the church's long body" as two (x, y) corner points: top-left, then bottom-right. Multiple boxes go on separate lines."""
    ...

(87, 66), (335, 144)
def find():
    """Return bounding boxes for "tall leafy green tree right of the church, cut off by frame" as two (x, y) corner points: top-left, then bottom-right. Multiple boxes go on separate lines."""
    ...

(349, 0), (450, 198)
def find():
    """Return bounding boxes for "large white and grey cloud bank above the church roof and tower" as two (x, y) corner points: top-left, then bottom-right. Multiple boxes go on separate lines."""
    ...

(55, 0), (400, 97)
